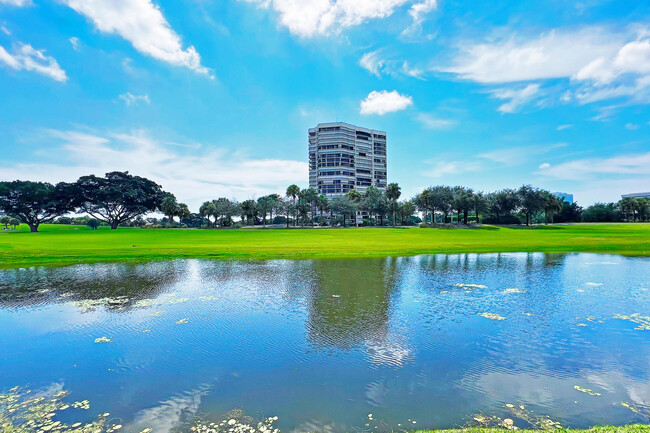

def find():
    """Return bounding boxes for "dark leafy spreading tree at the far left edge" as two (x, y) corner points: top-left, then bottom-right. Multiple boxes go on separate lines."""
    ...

(0, 180), (75, 233)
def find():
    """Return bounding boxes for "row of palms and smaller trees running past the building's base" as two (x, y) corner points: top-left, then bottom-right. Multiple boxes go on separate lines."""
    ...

(194, 183), (563, 227)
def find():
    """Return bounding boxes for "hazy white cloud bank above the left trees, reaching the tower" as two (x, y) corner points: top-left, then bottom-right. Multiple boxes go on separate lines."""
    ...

(0, 130), (308, 210)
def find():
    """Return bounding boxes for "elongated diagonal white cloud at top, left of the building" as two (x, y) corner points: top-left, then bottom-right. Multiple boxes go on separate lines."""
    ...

(63, 0), (210, 74)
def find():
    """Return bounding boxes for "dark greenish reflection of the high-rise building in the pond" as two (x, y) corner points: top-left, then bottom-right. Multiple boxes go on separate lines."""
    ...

(307, 259), (398, 349)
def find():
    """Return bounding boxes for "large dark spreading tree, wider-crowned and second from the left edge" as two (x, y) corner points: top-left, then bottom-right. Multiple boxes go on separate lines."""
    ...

(74, 171), (166, 230)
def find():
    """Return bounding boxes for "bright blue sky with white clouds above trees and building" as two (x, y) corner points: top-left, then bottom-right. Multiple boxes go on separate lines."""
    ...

(0, 0), (650, 210)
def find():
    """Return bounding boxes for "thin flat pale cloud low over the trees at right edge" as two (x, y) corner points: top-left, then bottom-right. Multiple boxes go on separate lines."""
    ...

(540, 153), (650, 180)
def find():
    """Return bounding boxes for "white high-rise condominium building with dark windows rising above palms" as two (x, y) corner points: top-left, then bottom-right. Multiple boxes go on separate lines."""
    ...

(309, 122), (387, 197)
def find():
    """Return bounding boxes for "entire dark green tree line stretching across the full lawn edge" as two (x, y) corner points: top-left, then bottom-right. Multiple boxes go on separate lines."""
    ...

(0, 171), (650, 232)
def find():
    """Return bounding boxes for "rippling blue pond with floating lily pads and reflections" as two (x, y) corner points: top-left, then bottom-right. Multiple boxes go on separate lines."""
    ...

(0, 253), (650, 432)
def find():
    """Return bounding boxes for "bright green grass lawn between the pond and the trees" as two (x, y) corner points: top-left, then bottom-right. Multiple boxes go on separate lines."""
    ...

(0, 224), (650, 268)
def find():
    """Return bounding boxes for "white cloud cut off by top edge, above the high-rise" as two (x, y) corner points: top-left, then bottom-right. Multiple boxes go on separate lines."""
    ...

(238, 0), (409, 38)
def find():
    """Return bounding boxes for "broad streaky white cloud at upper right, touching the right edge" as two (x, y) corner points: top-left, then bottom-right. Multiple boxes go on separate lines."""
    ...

(438, 26), (650, 106)
